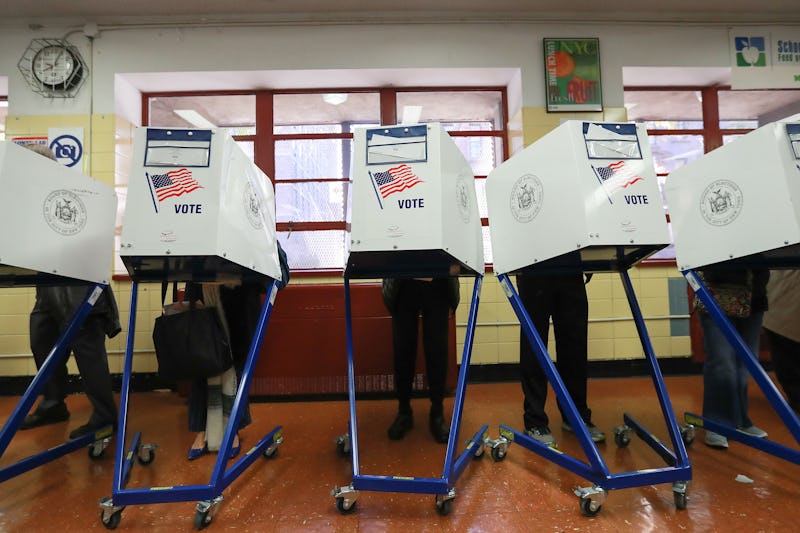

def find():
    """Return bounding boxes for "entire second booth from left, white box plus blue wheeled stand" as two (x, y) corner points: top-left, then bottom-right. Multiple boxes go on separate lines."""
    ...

(100, 128), (283, 529)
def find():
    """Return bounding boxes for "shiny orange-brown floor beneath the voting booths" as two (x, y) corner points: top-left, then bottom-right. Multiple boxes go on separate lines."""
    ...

(0, 376), (800, 533)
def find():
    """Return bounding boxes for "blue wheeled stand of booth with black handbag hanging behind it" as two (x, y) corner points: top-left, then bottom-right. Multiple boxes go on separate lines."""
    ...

(100, 281), (283, 529)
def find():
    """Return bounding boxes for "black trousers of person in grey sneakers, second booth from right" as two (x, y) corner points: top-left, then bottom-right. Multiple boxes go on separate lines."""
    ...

(517, 273), (592, 429)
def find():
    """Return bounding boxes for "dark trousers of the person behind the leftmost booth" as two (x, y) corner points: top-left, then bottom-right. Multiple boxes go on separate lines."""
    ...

(30, 311), (117, 425)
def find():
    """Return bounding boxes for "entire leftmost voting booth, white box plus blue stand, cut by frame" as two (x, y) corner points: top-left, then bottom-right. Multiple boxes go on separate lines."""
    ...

(0, 142), (117, 482)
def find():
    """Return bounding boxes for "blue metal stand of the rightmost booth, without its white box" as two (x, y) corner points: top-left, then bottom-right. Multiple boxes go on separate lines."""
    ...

(683, 270), (800, 464)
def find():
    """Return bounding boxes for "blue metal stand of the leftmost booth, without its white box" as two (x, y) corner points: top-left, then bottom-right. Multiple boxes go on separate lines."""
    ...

(0, 283), (113, 482)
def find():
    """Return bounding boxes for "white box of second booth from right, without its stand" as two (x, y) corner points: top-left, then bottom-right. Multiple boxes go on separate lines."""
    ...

(486, 120), (669, 273)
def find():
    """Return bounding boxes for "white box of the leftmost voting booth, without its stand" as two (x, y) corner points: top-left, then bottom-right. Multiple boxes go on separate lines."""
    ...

(0, 142), (117, 285)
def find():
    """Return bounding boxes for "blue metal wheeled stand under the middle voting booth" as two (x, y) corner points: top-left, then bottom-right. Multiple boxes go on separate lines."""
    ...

(331, 276), (488, 515)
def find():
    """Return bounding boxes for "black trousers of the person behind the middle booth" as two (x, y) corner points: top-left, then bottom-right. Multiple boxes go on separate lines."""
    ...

(392, 279), (450, 412)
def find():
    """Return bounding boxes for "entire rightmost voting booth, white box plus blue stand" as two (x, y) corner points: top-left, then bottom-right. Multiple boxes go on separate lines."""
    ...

(665, 122), (800, 463)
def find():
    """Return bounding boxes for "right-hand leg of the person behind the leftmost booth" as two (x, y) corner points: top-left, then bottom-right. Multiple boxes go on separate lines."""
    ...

(70, 315), (117, 438)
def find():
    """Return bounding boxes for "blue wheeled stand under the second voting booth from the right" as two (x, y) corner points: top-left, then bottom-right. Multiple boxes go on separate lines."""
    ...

(487, 270), (692, 516)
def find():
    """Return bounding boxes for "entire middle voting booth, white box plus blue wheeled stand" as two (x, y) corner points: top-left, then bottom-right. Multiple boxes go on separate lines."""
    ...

(333, 123), (487, 514)
